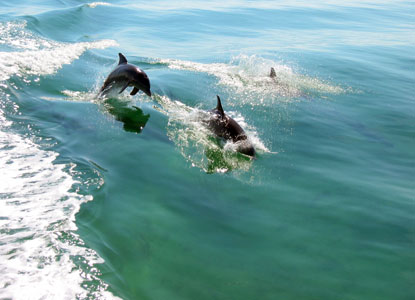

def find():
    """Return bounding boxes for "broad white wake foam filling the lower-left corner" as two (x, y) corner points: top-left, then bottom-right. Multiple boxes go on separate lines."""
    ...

(0, 110), (120, 299)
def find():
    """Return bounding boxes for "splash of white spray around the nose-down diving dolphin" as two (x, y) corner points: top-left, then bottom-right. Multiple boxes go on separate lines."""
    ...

(154, 95), (270, 173)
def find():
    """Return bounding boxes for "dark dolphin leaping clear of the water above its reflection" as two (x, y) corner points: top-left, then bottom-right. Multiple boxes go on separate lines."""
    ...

(100, 53), (151, 97)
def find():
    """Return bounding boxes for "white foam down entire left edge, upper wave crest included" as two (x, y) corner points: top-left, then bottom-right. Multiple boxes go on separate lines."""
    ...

(0, 19), (116, 300)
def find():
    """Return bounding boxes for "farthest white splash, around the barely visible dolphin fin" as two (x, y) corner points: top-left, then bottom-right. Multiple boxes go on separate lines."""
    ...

(159, 55), (344, 102)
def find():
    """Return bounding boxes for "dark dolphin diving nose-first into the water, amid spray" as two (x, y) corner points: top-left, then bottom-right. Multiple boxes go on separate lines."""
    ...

(208, 96), (255, 157)
